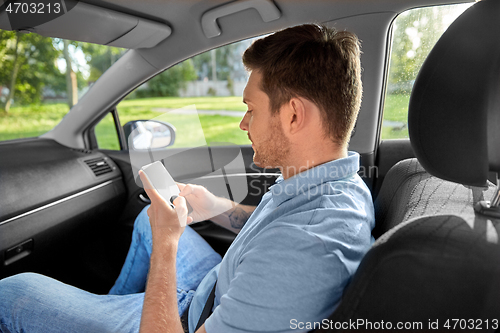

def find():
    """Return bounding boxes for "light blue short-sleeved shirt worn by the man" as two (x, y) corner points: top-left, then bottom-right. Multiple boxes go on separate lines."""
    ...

(188, 152), (375, 333)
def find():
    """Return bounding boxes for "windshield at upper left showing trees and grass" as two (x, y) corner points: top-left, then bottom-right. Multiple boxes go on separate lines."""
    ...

(0, 30), (126, 141)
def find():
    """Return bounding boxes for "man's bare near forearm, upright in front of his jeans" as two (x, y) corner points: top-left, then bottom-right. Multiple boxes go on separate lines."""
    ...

(140, 241), (184, 333)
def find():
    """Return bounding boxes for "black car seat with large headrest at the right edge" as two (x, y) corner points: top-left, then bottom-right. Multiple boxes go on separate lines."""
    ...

(318, 0), (500, 332)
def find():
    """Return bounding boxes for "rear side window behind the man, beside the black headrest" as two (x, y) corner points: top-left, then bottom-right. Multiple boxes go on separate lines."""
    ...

(381, 3), (472, 139)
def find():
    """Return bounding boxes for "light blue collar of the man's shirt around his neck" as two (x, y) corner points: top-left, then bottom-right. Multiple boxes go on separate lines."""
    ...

(269, 151), (359, 205)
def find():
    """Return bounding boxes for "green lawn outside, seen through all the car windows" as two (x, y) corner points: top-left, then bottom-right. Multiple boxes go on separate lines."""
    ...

(0, 95), (409, 149)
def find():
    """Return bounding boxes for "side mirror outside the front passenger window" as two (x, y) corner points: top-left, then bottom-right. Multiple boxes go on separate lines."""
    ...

(123, 120), (175, 150)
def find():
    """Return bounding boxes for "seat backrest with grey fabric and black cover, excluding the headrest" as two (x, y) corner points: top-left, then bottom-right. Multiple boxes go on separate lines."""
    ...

(318, 159), (500, 326)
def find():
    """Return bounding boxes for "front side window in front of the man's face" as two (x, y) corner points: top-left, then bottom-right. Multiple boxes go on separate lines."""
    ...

(108, 39), (260, 148)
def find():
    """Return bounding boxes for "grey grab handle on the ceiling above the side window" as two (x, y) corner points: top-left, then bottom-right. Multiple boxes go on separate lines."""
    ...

(201, 0), (281, 38)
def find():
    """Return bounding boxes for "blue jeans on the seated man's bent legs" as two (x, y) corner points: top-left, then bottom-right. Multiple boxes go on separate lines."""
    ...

(0, 207), (221, 333)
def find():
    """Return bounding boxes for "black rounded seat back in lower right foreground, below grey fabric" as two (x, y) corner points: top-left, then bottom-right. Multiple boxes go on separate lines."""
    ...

(319, 215), (500, 332)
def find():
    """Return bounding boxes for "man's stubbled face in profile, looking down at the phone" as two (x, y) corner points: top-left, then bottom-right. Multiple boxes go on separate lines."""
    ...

(240, 71), (290, 169)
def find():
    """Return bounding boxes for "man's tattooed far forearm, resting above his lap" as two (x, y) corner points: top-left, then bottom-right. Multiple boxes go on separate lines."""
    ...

(210, 198), (256, 234)
